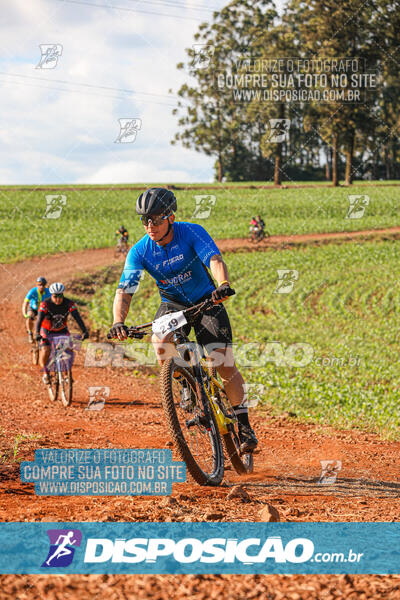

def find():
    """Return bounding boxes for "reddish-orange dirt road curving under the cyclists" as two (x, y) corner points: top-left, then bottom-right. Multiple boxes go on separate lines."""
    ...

(0, 228), (400, 600)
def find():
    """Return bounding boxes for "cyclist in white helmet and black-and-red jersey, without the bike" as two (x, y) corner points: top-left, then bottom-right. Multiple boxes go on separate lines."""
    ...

(36, 283), (89, 384)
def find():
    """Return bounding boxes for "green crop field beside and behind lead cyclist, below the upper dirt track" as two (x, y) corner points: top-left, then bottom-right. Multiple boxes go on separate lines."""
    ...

(90, 241), (400, 439)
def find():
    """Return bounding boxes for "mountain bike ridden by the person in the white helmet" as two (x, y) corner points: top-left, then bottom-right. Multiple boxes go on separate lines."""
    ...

(47, 333), (81, 407)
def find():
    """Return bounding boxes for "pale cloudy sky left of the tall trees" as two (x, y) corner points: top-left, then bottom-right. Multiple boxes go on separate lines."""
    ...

(0, 0), (281, 185)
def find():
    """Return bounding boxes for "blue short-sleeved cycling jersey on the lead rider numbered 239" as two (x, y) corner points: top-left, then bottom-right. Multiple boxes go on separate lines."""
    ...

(118, 222), (221, 305)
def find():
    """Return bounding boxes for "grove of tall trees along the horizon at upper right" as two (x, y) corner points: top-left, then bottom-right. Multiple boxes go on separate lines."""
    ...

(171, 0), (400, 185)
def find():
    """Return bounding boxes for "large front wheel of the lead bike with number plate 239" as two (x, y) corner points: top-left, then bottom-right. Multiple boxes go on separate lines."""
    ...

(161, 358), (224, 485)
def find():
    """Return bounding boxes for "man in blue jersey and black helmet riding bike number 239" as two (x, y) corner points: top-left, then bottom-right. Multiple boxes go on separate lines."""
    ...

(110, 188), (257, 452)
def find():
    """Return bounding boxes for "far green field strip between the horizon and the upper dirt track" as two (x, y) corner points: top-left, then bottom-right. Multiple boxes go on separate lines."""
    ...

(0, 183), (400, 262)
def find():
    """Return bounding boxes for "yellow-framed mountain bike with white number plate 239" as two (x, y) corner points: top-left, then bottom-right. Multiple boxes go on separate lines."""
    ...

(108, 299), (253, 486)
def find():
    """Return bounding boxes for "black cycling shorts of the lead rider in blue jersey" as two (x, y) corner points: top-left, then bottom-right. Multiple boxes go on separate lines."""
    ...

(154, 295), (232, 348)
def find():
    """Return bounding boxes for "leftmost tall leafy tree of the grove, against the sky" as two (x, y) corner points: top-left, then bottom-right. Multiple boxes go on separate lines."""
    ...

(172, 0), (277, 181)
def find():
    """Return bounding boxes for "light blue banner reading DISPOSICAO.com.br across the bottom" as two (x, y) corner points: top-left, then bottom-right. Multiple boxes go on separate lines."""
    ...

(0, 522), (400, 574)
